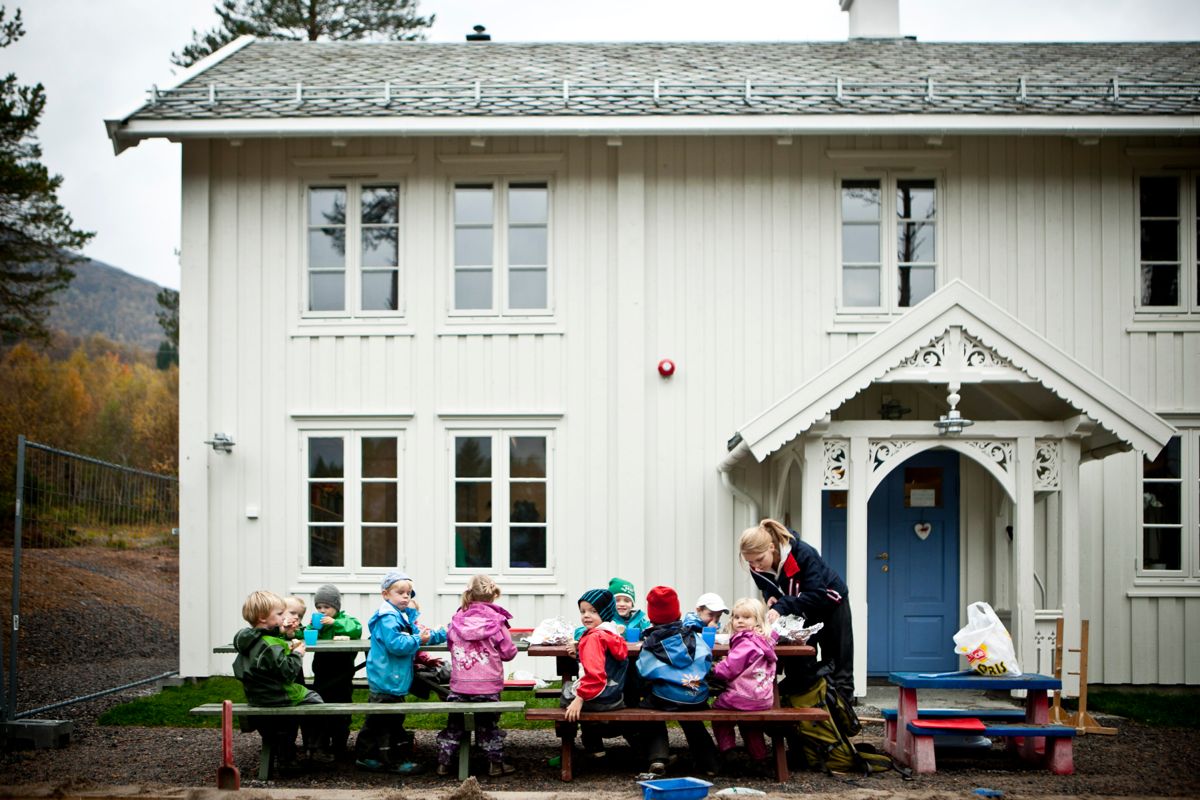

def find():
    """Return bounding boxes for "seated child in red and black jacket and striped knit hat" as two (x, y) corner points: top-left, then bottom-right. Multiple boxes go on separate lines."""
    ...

(562, 589), (629, 758)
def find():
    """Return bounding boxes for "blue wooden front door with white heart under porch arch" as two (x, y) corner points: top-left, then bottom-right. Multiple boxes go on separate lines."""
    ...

(868, 450), (959, 675)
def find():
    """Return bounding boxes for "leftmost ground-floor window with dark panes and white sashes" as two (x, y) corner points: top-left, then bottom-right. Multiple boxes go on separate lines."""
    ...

(305, 431), (401, 571)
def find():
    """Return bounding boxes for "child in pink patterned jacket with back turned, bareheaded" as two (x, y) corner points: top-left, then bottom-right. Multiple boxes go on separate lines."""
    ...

(438, 575), (517, 777)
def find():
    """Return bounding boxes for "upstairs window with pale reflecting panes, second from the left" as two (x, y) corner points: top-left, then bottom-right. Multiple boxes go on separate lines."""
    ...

(454, 180), (550, 315)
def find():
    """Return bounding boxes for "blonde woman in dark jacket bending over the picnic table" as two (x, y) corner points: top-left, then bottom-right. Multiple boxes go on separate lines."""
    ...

(738, 519), (854, 703)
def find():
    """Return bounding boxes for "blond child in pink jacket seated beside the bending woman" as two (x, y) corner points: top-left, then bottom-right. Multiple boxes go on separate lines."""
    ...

(713, 597), (775, 764)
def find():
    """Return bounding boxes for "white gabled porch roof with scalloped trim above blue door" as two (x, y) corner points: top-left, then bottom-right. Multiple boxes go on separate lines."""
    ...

(724, 279), (1175, 469)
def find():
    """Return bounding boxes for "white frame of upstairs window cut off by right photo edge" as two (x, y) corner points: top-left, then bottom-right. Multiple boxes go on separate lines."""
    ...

(1133, 169), (1200, 321)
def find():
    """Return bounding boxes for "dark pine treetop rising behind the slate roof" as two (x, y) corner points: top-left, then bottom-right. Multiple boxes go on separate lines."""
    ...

(170, 0), (433, 67)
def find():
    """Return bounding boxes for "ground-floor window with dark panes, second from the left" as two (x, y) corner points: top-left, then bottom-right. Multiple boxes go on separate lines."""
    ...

(451, 431), (552, 573)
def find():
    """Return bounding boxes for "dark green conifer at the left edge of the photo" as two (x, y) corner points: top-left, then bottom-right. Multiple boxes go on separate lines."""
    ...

(0, 6), (92, 342)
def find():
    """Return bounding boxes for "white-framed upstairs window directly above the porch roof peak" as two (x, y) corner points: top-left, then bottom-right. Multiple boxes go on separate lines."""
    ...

(839, 176), (937, 314)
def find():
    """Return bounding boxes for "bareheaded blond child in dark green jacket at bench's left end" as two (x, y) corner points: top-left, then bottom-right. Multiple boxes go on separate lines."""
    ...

(233, 591), (322, 769)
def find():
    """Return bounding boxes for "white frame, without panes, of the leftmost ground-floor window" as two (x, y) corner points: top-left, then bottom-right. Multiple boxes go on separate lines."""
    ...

(298, 421), (409, 582)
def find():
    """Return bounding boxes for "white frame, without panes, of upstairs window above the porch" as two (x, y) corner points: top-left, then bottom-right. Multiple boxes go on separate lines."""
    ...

(834, 167), (947, 324)
